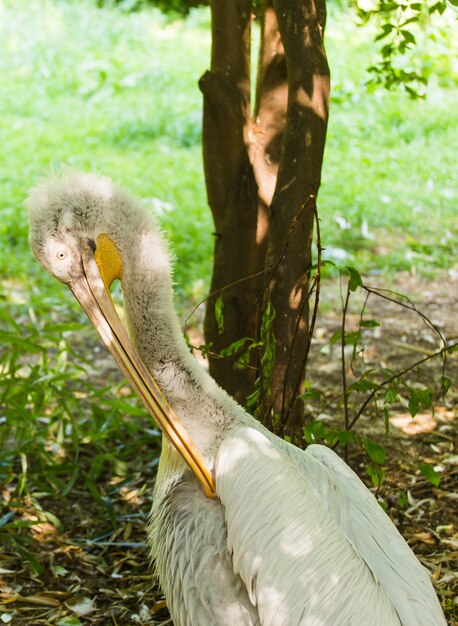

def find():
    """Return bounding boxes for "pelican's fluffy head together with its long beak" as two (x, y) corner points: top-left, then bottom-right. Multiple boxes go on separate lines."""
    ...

(26, 172), (214, 495)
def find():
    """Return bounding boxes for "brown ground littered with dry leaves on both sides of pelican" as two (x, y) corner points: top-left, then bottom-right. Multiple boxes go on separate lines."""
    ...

(0, 275), (458, 626)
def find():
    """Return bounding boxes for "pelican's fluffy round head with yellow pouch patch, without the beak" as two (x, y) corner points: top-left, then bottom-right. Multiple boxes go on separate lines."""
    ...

(26, 171), (161, 288)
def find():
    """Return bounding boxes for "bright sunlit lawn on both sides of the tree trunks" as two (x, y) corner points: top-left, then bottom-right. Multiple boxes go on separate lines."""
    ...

(0, 0), (458, 312)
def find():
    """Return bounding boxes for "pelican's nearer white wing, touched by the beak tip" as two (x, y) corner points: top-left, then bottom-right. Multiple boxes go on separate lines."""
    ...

(215, 426), (400, 626)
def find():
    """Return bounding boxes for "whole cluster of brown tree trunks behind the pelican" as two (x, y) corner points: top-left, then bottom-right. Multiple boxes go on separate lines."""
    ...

(201, 0), (329, 424)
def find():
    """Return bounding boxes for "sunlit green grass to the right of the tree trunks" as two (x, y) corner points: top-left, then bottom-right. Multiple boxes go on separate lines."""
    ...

(320, 7), (458, 272)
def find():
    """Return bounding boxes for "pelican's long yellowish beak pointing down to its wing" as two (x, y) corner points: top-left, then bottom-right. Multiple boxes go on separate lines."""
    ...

(69, 244), (216, 498)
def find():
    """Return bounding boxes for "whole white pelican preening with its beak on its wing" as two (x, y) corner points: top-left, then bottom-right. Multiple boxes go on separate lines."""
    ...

(27, 172), (446, 626)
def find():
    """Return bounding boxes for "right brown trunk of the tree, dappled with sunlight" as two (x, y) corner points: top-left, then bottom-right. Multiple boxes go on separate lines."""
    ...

(261, 0), (330, 432)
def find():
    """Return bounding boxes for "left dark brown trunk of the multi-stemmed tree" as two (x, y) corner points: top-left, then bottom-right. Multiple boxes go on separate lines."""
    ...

(200, 0), (264, 403)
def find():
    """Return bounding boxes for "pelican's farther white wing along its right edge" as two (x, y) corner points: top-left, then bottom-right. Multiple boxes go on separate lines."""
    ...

(298, 445), (446, 626)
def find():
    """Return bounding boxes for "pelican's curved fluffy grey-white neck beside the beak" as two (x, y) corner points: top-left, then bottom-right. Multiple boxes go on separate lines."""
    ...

(118, 228), (245, 469)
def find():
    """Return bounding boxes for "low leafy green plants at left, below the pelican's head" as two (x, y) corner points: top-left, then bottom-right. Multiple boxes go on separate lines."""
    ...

(0, 305), (160, 574)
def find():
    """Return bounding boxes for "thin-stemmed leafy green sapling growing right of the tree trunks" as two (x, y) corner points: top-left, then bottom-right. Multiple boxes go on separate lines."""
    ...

(300, 262), (458, 489)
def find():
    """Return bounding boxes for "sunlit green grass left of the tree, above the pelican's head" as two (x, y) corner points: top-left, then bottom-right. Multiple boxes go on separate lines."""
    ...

(0, 0), (212, 310)
